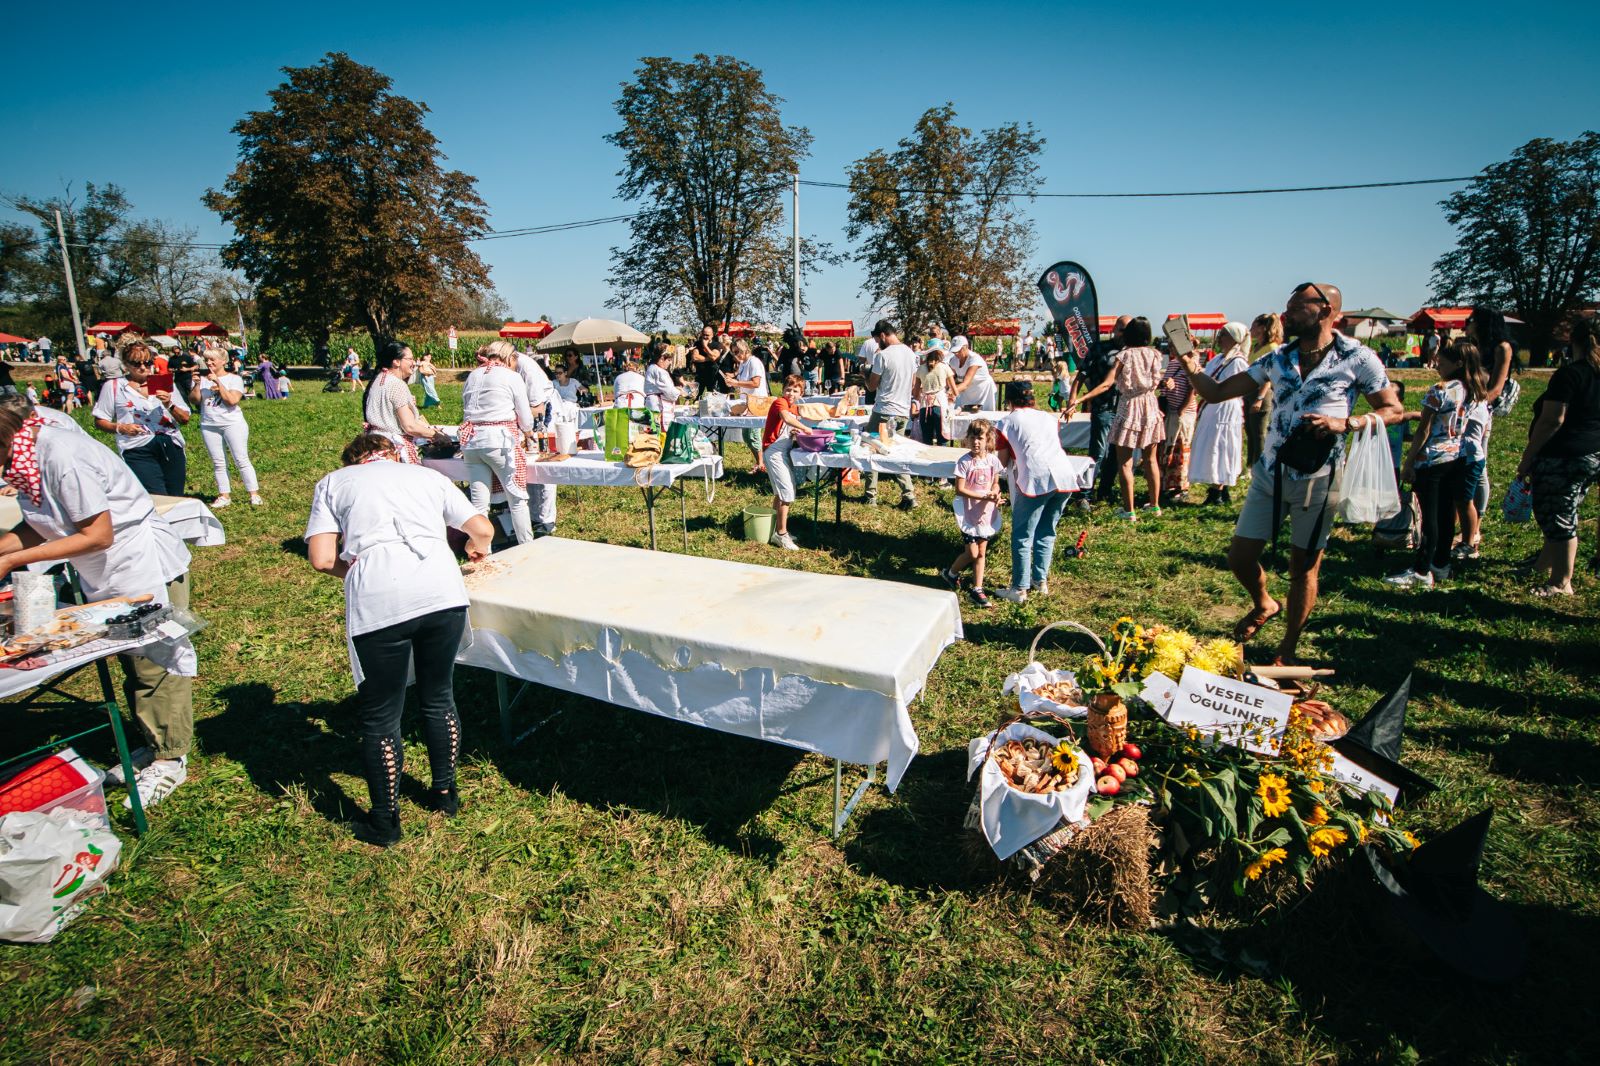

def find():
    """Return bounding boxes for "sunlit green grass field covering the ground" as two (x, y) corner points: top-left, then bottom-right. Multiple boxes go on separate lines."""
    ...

(0, 369), (1600, 1063)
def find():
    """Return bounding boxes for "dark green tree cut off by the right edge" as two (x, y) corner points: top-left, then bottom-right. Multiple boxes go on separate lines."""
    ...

(1434, 131), (1600, 365)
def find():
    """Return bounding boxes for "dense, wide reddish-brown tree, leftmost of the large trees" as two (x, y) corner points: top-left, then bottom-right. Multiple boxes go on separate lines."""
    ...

(205, 53), (488, 343)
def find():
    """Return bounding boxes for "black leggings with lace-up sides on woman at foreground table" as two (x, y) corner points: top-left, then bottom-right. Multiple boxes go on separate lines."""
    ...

(354, 607), (467, 813)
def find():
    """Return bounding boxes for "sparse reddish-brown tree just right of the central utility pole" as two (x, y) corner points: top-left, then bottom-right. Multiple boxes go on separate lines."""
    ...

(845, 104), (1045, 331)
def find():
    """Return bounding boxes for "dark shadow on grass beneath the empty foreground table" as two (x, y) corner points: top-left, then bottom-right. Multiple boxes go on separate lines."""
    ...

(456, 671), (818, 864)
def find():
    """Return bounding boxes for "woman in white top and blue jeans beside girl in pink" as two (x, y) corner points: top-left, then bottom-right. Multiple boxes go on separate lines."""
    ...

(995, 381), (1077, 603)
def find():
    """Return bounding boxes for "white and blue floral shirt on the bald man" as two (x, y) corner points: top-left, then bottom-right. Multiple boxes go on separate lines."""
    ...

(1250, 333), (1389, 482)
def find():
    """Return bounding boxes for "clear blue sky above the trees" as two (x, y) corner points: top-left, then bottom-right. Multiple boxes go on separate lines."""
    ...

(0, 0), (1600, 329)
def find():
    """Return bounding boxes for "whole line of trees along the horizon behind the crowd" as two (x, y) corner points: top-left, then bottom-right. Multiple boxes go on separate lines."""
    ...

(0, 44), (1600, 360)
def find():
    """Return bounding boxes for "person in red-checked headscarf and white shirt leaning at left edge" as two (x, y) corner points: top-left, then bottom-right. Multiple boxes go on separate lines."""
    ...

(0, 410), (195, 808)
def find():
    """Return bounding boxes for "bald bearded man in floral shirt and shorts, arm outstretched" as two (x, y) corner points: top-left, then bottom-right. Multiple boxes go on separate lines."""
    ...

(1184, 282), (1405, 663)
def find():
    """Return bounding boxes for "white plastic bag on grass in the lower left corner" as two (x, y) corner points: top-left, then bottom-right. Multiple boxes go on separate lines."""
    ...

(0, 808), (122, 944)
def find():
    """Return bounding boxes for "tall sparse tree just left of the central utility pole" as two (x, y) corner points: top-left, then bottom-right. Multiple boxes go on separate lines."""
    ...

(606, 56), (826, 327)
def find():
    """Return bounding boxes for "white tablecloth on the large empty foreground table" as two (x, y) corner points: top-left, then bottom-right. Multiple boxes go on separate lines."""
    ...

(458, 536), (962, 791)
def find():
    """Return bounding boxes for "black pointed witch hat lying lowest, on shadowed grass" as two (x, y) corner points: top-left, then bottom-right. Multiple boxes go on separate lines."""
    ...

(1363, 810), (1528, 981)
